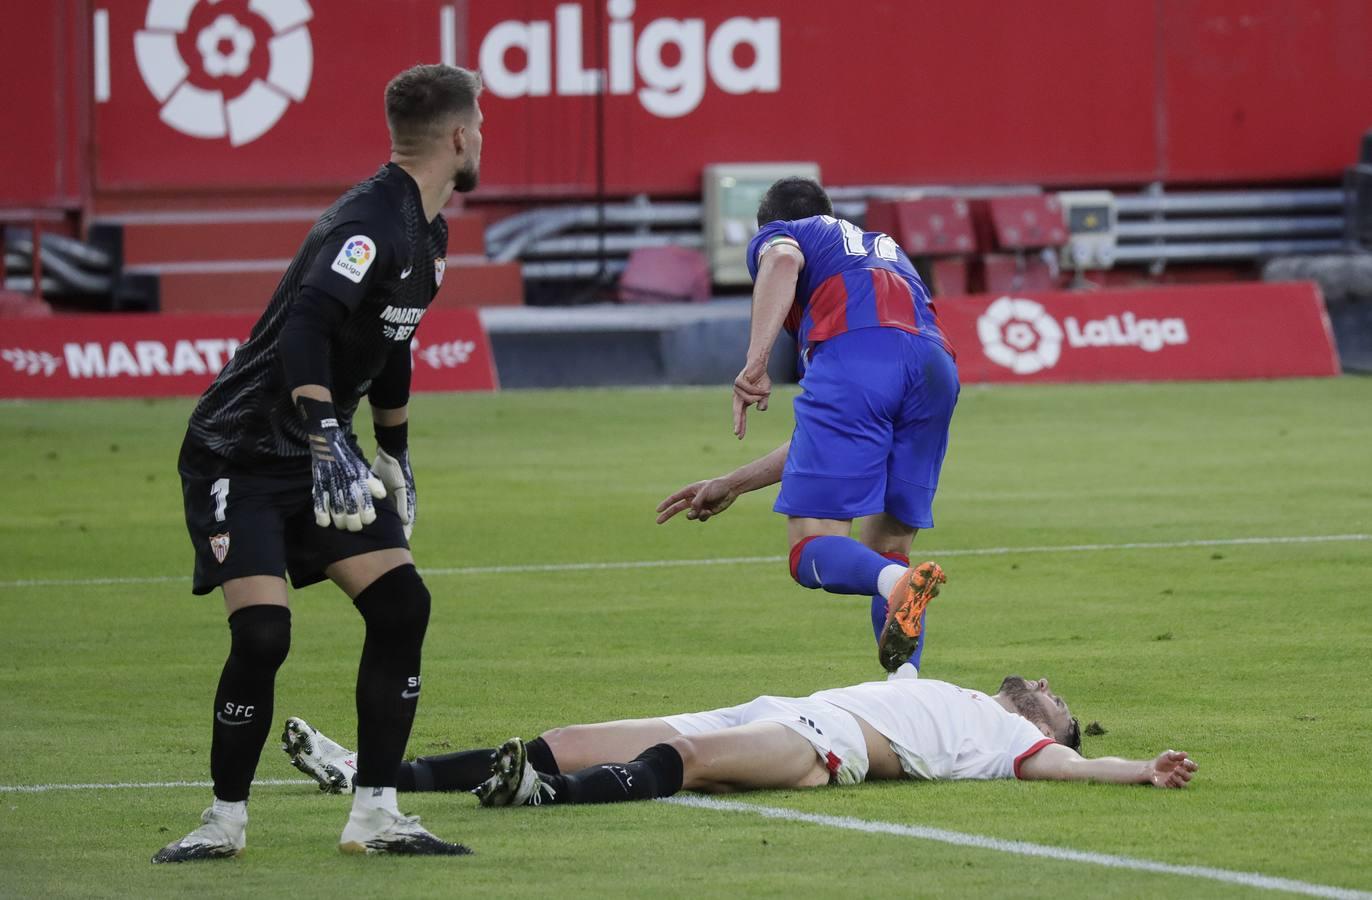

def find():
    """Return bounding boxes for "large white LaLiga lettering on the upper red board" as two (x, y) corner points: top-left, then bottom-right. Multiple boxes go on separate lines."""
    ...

(479, 0), (781, 118)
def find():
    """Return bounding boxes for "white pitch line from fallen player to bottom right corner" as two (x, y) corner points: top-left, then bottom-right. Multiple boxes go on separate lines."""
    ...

(663, 797), (1372, 900)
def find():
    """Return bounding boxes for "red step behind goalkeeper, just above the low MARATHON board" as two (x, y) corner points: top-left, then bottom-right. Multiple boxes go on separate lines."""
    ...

(139, 255), (524, 313)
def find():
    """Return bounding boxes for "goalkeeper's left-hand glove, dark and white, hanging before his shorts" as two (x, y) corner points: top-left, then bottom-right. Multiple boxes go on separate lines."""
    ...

(299, 396), (386, 531)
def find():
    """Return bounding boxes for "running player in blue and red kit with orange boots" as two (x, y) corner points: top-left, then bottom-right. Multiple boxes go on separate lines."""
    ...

(657, 178), (959, 671)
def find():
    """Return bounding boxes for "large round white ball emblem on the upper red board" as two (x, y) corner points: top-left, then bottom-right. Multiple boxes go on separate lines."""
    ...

(133, 0), (314, 147)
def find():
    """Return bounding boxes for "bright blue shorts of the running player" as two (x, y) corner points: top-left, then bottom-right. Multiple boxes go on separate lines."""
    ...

(772, 328), (959, 528)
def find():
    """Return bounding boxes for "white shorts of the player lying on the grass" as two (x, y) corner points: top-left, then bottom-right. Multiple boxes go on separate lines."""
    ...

(663, 697), (867, 785)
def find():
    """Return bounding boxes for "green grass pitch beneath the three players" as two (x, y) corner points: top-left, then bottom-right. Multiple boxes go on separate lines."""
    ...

(0, 377), (1372, 897)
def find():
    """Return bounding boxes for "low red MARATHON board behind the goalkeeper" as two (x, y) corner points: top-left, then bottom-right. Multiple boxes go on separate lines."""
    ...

(0, 309), (497, 399)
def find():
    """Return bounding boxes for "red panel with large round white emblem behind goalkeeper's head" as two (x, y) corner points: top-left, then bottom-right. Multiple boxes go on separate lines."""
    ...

(92, 0), (443, 191)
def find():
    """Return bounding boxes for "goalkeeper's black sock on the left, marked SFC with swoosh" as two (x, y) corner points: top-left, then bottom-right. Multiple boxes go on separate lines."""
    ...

(210, 604), (291, 803)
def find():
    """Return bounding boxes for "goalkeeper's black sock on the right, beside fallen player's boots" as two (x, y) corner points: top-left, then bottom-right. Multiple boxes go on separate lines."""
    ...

(353, 565), (429, 788)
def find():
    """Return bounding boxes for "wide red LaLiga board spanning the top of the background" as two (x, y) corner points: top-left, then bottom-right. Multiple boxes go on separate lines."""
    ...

(58, 0), (1372, 196)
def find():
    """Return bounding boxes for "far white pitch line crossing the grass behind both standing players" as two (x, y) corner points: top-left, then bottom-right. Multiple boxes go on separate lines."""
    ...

(0, 534), (1372, 587)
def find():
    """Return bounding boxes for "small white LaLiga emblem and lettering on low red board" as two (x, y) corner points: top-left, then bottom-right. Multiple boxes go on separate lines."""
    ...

(977, 296), (1190, 375)
